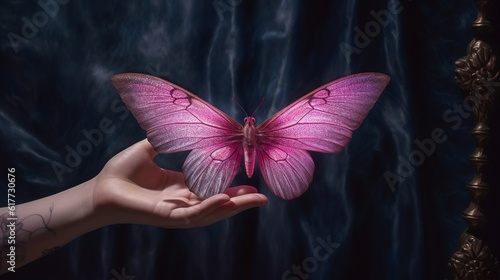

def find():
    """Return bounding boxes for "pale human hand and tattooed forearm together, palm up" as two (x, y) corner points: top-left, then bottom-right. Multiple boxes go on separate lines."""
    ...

(0, 140), (268, 273)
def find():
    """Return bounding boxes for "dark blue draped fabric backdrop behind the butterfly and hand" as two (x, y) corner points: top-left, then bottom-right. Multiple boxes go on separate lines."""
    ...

(0, 0), (484, 280)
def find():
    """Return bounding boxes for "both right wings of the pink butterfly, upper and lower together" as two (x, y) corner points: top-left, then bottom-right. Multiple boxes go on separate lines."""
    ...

(256, 73), (390, 199)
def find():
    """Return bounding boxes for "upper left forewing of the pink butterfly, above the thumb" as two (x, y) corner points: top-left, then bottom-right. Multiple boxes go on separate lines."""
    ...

(111, 73), (242, 153)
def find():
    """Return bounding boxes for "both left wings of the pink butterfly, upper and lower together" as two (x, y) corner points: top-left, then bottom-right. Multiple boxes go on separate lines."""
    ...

(111, 73), (242, 198)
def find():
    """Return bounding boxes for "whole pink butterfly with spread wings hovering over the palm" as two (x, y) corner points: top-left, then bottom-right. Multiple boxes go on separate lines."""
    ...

(112, 73), (390, 200)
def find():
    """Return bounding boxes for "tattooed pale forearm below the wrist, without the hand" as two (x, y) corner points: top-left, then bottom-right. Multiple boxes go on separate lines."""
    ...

(0, 179), (104, 273)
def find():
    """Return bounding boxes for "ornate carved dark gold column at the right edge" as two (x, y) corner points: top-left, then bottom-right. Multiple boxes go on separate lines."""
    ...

(448, 0), (500, 280)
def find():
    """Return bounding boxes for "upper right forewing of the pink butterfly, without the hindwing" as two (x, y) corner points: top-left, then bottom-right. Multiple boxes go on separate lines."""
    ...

(257, 73), (389, 153)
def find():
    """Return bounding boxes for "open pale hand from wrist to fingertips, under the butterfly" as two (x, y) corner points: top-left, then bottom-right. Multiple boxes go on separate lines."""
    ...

(92, 140), (268, 228)
